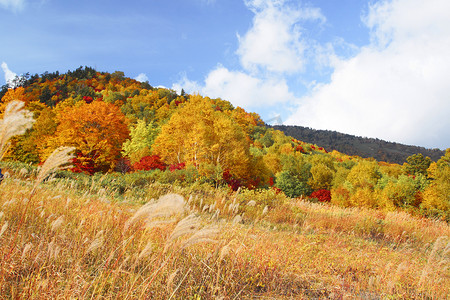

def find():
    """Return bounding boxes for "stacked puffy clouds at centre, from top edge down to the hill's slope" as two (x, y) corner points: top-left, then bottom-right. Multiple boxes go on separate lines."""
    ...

(173, 0), (325, 110)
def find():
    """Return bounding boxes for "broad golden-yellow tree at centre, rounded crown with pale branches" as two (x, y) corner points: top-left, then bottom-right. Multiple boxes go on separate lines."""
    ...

(153, 95), (251, 182)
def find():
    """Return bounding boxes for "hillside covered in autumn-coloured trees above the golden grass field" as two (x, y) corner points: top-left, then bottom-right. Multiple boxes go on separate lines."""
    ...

(0, 67), (450, 221)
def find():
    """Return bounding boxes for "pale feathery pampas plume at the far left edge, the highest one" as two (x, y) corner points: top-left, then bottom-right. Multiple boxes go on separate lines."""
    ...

(0, 100), (35, 160)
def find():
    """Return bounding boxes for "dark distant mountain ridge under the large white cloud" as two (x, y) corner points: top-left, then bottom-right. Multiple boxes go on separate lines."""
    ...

(271, 125), (445, 164)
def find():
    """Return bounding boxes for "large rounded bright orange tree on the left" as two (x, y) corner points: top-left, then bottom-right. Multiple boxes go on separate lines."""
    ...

(50, 101), (129, 171)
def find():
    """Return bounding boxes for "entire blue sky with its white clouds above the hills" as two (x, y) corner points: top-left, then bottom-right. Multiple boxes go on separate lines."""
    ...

(0, 0), (450, 149)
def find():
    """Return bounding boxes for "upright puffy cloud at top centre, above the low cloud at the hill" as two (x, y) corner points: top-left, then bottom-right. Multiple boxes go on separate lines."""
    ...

(237, 0), (325, 72)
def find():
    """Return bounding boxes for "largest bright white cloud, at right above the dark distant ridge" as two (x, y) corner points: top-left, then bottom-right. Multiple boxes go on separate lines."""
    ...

(287, 0), (450, 148)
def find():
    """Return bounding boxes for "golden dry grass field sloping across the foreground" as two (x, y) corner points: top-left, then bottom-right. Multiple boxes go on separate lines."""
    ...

(0, 172), (450, 299)
